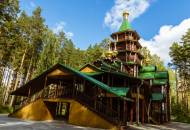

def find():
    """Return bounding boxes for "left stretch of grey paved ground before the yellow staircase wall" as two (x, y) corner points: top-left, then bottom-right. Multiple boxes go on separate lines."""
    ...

(0, 115), (103, 130)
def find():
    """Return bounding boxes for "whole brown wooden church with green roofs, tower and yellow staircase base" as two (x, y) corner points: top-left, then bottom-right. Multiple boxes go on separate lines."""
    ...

(10, 12), (170, 129)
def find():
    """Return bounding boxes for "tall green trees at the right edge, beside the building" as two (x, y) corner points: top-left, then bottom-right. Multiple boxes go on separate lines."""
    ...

(169, 29), (190, 123)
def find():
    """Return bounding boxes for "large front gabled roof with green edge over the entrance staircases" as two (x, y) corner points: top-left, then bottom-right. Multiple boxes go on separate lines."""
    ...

(11, 64), (131, 100)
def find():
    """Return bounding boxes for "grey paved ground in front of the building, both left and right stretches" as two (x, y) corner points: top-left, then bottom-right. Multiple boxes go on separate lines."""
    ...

(0, 115), (190, 130)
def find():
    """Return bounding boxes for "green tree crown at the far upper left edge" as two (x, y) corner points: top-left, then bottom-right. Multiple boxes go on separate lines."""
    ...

(0, 0), (19, 64)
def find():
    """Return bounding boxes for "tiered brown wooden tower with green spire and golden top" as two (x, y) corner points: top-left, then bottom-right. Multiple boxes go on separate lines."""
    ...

(109, 12), (143, 77)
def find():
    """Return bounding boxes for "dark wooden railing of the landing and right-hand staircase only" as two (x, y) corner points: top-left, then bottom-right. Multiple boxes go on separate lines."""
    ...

(44, 88), (119, 124)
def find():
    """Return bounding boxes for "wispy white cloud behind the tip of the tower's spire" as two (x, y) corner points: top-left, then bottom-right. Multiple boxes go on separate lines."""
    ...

(104, 0), (151, 31)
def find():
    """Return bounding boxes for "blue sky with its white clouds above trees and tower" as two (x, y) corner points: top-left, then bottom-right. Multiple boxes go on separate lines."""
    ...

(20, 0), (190, 62)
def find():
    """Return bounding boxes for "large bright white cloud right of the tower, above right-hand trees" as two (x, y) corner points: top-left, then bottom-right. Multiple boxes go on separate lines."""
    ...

(140, 18), (190, 63)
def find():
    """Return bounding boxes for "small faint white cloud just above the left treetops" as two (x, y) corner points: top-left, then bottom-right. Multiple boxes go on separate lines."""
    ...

(52, 21), (74, 39)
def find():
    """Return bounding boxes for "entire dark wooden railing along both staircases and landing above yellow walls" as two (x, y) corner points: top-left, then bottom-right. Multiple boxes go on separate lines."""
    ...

(15, 87), (121, 124)
